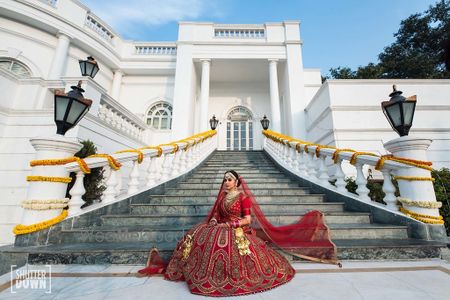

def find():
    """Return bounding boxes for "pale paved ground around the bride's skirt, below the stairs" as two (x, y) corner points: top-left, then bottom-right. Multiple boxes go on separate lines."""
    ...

(0, 260), (450, 300)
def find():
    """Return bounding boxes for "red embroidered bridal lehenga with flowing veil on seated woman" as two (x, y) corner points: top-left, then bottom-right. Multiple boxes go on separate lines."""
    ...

(139, 177), (337, 296)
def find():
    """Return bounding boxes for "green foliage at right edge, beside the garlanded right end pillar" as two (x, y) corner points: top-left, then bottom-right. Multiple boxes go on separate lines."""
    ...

(431, 168), (450, 235)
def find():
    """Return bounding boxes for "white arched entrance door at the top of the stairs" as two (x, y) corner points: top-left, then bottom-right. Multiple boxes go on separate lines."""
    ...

(227, 106), (253, 151)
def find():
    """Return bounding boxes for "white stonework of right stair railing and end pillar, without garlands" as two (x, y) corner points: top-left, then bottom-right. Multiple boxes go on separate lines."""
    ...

(263, 137), (439, 221)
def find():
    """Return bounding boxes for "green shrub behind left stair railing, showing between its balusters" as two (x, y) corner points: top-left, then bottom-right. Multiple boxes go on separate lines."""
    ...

(66, 140), (106, 208)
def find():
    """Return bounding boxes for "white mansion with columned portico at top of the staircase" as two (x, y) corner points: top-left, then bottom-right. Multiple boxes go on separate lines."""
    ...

(0, 0), (450, 244)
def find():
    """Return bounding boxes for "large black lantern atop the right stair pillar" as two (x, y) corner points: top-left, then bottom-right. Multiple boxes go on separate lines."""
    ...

(381, 85), (417, 137)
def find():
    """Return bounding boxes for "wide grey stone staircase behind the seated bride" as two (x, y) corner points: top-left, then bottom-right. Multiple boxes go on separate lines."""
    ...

(3, 151), (443, 264)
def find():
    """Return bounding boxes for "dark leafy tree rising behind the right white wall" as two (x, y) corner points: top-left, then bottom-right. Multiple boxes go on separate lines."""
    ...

(330, 0), (450, 79)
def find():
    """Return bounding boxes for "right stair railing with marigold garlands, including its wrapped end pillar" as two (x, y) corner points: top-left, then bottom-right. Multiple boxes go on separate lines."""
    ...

(263, 130), (443, 225)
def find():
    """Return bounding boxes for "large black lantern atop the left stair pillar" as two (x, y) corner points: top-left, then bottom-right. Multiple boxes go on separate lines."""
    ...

(55, 80), (92, 135)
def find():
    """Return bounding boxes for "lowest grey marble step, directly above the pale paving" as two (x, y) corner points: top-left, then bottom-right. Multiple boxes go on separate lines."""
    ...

(2, 239), (445, 267)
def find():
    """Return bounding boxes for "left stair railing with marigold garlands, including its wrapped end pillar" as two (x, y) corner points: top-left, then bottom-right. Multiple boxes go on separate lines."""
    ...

(13, 130), (217, 234)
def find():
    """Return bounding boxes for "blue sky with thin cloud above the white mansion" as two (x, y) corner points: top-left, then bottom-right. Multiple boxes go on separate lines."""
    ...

(81, 0), (437, 76)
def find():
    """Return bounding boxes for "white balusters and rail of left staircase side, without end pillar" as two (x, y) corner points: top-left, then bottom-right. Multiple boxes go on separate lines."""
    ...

(65, 131), (218, 216)
